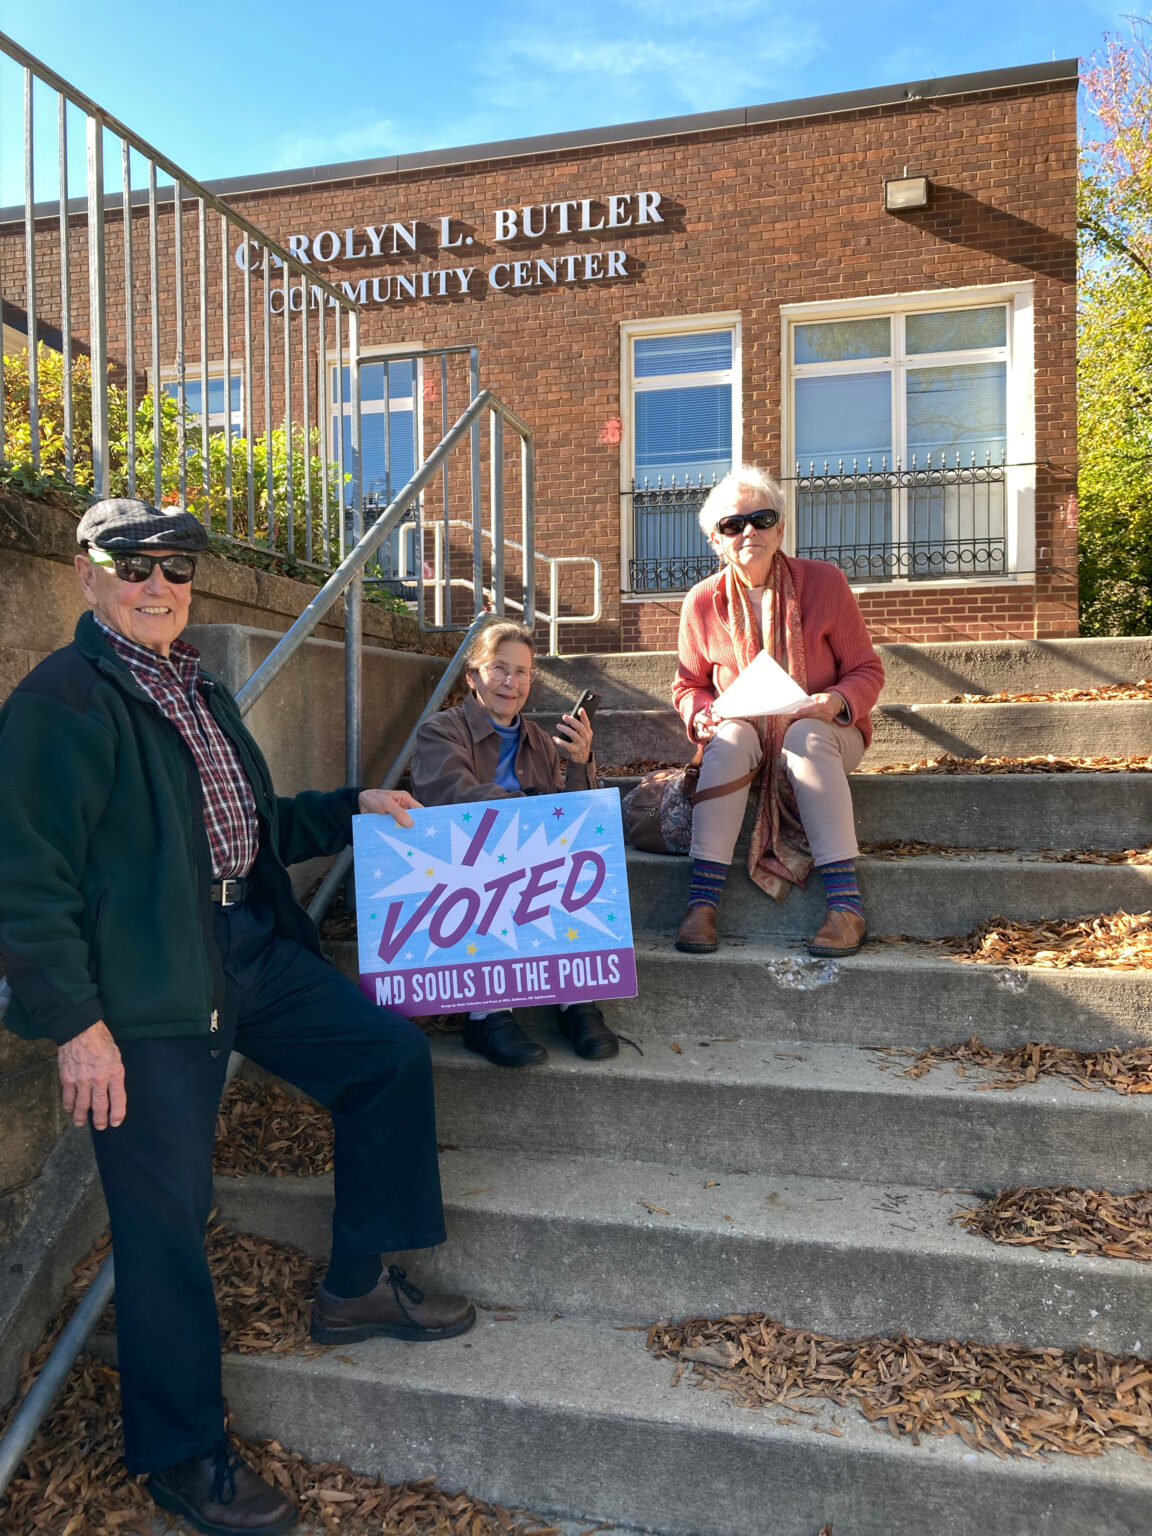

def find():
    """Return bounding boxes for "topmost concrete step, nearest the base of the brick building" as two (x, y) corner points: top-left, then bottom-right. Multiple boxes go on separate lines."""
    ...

(531, 636), (1152, 710)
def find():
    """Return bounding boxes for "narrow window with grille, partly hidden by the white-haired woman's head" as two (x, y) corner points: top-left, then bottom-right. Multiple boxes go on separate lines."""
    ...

(622, 315), (740, 591)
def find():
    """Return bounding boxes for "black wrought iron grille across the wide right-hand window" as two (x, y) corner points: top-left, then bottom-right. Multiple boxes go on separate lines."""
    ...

(794, 455), (1008, 582)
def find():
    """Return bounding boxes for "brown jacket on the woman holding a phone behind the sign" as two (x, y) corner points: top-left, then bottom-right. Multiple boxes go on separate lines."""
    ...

(412, 694), (599, 805)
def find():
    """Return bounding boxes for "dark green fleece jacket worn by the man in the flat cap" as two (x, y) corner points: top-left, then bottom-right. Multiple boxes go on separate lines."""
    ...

(0, 613), (358, 1043)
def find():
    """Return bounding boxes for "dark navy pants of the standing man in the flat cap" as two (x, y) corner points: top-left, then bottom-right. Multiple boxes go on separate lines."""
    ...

(85, 899), (444, 1473)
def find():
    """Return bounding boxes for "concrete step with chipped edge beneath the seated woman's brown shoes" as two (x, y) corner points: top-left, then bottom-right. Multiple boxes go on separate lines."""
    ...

(326, 934), (1152, 1052)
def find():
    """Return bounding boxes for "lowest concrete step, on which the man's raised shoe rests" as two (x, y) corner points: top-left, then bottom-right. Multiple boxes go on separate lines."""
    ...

(224, 1307), (1152, 1536)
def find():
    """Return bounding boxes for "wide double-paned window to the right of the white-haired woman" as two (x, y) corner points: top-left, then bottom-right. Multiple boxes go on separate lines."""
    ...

(783, 290), (1032, 582)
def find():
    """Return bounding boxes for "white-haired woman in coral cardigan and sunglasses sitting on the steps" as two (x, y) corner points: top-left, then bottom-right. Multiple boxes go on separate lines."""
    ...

(673, 465), (885, 957)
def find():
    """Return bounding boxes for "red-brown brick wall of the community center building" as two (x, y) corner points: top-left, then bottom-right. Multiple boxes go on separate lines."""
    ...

(0, 81), (1077, 650)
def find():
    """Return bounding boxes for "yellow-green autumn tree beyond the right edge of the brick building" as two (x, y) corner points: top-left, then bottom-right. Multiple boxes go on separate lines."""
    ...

(1077, 17), (1152, 634)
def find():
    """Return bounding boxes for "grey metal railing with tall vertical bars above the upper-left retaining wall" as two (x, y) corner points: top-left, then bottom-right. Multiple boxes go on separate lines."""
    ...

(0, 32), (361, 565)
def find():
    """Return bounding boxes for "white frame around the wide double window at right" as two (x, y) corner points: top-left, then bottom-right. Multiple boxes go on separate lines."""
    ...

(780, 283), (1035, 591)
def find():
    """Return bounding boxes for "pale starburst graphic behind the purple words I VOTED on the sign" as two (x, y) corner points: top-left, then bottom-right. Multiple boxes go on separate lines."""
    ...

(367, 809), (614, 963)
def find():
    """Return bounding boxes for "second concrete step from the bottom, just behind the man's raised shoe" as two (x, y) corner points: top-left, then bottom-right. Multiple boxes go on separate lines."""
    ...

(215, 1155), (1152, 1353)
